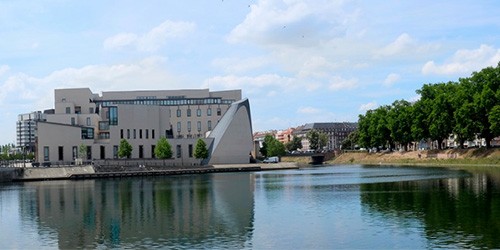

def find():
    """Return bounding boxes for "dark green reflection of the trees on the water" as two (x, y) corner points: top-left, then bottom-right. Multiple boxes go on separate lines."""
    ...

(361, 168), (500, 248)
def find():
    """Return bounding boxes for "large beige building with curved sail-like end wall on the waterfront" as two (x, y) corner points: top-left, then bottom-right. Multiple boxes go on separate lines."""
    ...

(36, 88), (252, 165)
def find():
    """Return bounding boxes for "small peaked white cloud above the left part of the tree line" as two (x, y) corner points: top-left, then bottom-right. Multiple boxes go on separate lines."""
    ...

(374, 33), (439, 58)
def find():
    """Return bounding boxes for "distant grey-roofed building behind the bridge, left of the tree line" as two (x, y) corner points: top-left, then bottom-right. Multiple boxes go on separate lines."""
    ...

(293, 122), (358, 151)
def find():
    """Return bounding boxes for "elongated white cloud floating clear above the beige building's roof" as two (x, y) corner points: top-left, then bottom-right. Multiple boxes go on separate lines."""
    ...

(103, 20), (196, 52)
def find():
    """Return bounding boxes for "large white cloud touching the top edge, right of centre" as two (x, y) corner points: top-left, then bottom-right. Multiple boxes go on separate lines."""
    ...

(227, 0), (352, 46)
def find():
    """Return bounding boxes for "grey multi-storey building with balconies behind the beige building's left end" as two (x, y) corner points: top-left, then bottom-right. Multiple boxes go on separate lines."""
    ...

(16, 111), (46, 153)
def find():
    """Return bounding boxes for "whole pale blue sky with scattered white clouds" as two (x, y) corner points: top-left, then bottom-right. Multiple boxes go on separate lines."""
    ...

(0, 0), (500, 145)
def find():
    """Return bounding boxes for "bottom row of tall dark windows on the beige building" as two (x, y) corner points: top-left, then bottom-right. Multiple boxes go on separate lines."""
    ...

(43, 144), (193, 162)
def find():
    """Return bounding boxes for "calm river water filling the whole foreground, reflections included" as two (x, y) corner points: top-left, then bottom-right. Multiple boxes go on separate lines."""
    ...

(0, 165), (500, 249)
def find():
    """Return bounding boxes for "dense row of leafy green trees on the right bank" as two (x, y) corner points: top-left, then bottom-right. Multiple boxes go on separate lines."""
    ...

(352, 62), (500, 150)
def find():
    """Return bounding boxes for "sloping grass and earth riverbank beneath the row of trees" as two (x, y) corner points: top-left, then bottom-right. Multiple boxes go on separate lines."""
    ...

(327, 148), (500, 167)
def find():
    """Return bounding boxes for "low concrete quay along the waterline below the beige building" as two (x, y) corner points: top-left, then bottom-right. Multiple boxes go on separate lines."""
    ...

(0, 162), (299, 181)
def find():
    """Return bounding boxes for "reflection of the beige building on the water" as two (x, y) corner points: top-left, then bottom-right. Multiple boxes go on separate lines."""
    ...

(21, 174), (255, 248)
